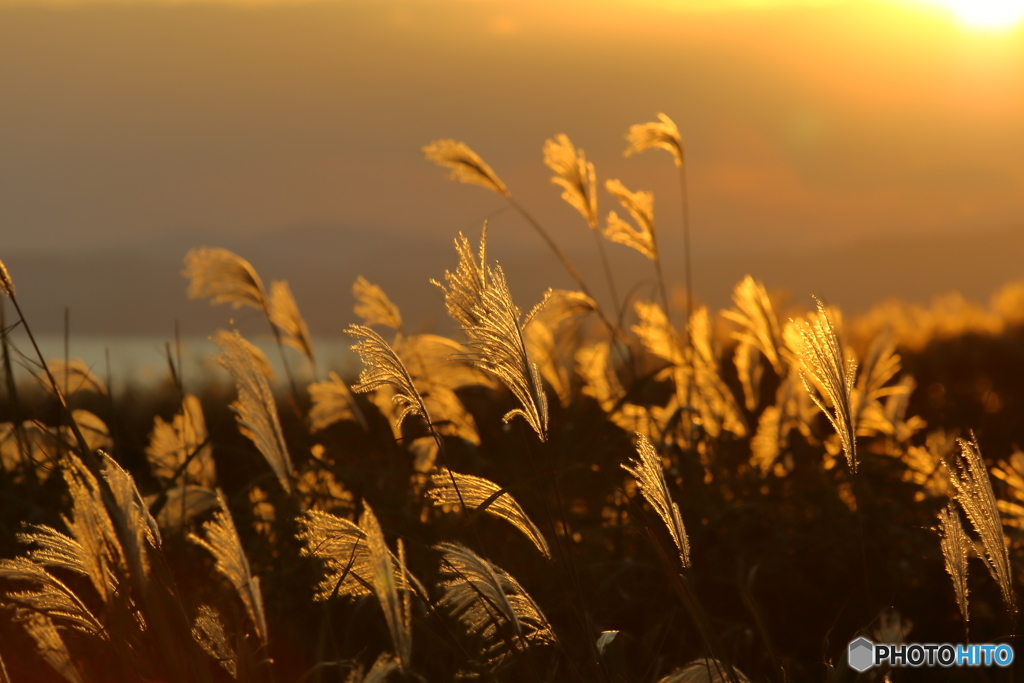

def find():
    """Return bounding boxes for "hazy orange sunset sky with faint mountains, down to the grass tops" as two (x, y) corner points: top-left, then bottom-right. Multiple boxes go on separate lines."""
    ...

(0, 0), (1024, 334)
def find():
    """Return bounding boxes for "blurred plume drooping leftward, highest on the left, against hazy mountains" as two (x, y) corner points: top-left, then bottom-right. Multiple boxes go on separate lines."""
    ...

(181, 247), (266, 310)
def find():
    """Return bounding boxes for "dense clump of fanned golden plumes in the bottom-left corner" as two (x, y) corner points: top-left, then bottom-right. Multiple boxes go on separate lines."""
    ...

(0, 453), (178, 680)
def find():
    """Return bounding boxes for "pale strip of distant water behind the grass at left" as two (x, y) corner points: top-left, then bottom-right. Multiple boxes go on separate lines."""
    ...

(2, 331), (360, 393)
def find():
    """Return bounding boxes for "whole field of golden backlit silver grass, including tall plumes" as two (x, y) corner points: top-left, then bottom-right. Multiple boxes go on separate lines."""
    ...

(0, 114), (1024, 683)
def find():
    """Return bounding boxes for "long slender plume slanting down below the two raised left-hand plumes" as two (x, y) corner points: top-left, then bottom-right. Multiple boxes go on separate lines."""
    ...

(214, 330), (293, 493)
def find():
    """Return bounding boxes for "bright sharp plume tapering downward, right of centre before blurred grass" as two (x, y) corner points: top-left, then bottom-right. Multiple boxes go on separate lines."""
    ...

(796, 299), (857, 472)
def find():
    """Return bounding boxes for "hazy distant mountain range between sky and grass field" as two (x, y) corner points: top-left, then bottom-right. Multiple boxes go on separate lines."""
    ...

(0, 226), (1024, 336)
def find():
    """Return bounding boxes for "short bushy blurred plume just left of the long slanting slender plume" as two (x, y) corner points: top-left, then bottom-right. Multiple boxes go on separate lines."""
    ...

(145, 394), (217, 486)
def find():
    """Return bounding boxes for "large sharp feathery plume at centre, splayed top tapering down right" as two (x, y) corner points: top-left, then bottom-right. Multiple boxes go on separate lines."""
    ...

(434, 229), (548, 441)
